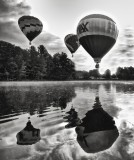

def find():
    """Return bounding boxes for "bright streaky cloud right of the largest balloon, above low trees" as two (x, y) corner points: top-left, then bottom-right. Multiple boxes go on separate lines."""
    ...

(100, 27), (134, 73)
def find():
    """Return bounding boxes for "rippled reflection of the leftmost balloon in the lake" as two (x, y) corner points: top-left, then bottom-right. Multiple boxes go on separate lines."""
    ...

(16, 120), (41, 145)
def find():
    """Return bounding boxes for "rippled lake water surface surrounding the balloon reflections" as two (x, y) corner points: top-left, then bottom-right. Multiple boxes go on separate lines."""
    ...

(0, 81), (134, 160)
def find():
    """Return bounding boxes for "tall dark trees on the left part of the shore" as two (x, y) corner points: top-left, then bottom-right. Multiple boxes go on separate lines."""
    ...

(0, 41), (75, 81)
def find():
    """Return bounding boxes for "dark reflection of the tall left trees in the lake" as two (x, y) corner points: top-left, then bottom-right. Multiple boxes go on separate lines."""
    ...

(0, 86), (76, 115)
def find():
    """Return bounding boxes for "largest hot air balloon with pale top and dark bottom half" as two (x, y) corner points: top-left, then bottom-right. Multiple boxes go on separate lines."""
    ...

(77, 14), (118, 68)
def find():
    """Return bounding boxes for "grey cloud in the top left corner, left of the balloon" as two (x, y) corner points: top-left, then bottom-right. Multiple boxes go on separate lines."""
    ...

(0, 0), (30, 44)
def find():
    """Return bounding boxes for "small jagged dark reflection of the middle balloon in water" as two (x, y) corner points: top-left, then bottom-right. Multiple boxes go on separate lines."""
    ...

(64, 106), (81, 128)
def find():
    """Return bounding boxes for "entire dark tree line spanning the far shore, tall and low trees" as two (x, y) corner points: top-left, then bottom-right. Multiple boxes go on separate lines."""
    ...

(0, 41), (134, 81)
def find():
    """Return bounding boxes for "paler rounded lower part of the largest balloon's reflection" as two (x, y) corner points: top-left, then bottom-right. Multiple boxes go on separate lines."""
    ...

(77, 127), (119, 153)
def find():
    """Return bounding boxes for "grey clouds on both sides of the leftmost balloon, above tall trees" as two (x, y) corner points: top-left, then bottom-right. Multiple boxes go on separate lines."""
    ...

(0, 0), (67, 54)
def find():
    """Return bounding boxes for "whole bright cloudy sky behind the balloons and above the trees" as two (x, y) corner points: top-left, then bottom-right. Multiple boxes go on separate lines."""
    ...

(0, 0), (134, 73)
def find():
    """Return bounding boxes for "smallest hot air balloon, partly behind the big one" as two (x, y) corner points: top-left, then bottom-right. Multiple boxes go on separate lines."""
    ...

(64, 34), (80, 57)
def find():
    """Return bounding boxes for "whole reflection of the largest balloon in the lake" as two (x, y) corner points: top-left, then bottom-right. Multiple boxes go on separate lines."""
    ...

(75, 97), (119, 153)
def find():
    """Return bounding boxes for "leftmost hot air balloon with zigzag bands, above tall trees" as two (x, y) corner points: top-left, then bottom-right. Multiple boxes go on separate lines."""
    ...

(18, 16), (43, 44)
